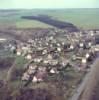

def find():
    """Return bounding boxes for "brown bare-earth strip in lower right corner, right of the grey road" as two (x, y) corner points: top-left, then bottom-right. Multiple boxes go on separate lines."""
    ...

(79, 58), (99, 100)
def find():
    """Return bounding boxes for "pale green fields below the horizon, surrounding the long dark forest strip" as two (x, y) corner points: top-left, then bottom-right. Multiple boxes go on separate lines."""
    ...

(0, 9), (99, 29)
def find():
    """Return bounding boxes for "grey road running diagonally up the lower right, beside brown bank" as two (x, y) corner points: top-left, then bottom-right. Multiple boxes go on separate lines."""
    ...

(70, 58), (99, 100)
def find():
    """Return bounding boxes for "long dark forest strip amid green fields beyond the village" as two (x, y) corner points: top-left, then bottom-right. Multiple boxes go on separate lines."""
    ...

(21, 15), (78, 32)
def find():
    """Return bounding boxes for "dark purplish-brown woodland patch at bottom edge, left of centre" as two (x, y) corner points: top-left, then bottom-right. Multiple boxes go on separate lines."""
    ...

(16, 89), (52, 100)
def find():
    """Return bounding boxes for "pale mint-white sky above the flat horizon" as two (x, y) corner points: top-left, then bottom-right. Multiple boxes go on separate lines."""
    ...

(0, 0), (99, 9)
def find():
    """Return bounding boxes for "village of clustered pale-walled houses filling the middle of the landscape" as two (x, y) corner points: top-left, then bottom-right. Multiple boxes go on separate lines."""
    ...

(0, 30), (99, 85)
